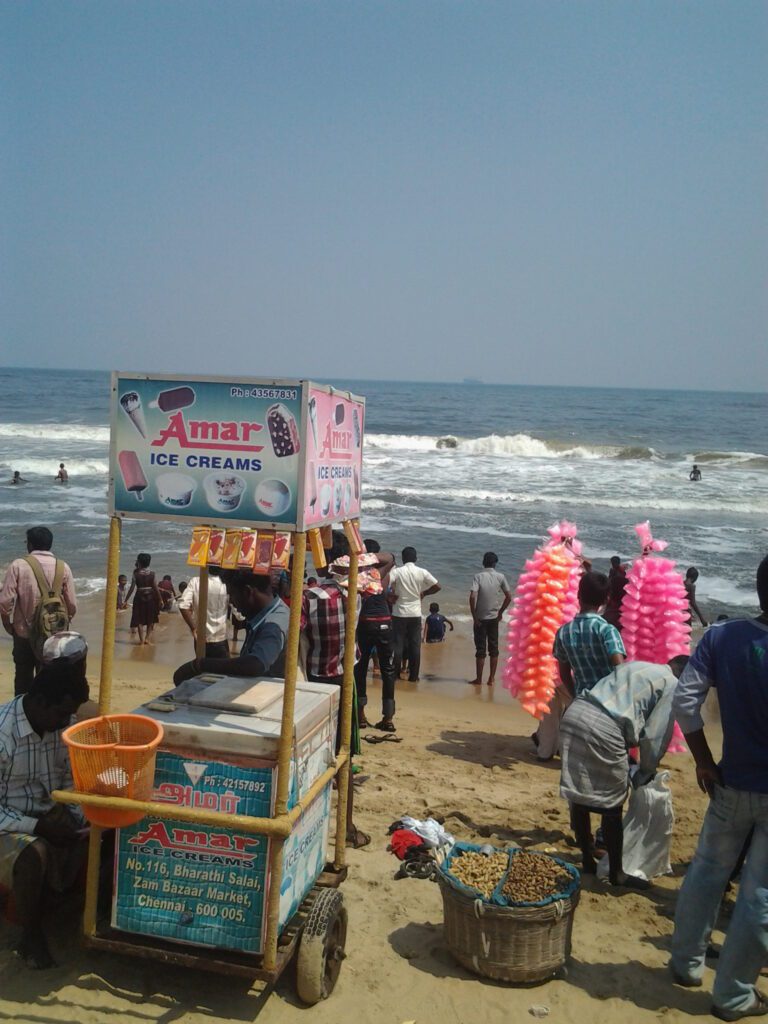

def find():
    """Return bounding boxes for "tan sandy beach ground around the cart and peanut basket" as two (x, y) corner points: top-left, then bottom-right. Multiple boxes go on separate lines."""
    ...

(0, 606), (710, 1024)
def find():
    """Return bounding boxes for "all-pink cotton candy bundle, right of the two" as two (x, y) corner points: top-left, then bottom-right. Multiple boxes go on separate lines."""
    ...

(622, 522), (690, 665)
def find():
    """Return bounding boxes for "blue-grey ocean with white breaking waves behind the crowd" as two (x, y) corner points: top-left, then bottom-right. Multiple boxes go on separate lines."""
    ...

(0, 369), (768, 622)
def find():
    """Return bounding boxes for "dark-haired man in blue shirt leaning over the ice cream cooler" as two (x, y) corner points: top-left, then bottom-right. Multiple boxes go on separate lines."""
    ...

(173, 569), (291, 686)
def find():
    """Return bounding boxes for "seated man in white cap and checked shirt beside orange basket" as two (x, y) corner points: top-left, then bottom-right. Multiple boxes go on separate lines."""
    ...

(0, 633), (88, 969)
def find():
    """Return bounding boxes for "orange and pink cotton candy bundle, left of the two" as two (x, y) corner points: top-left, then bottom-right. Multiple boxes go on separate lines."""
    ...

(503, 520), (582, 718)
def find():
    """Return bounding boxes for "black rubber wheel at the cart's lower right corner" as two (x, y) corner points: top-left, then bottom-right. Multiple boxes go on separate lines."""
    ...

(296, 889), (347, 1007)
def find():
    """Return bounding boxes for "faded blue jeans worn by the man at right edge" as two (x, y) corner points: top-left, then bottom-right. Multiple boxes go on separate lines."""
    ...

(672, 786), (768, 1010)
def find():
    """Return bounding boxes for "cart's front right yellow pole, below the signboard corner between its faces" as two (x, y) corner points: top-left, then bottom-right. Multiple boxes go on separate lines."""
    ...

(264, 534), (306, 971)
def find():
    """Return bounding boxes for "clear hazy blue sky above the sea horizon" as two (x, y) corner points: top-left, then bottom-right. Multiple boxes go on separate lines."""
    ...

(0, 0), (768, 390)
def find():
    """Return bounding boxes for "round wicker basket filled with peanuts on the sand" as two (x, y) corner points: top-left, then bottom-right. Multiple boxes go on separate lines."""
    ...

(437, 843), (580, 984)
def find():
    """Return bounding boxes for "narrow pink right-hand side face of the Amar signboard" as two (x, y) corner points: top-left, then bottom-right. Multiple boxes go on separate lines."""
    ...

(304, 385), (366, 527)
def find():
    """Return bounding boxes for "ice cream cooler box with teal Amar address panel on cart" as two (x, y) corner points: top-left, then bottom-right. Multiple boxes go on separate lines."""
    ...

(112, 676), (340, 953)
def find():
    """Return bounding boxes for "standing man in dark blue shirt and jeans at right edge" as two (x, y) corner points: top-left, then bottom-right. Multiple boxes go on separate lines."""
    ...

(671, 557), (768, 1021)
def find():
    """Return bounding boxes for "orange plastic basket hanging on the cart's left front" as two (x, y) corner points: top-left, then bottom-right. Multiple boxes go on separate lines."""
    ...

(62, 715), (163, 828)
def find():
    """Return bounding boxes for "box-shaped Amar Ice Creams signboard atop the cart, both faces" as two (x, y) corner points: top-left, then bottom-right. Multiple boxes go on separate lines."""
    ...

(110, 373), (366, 529)
